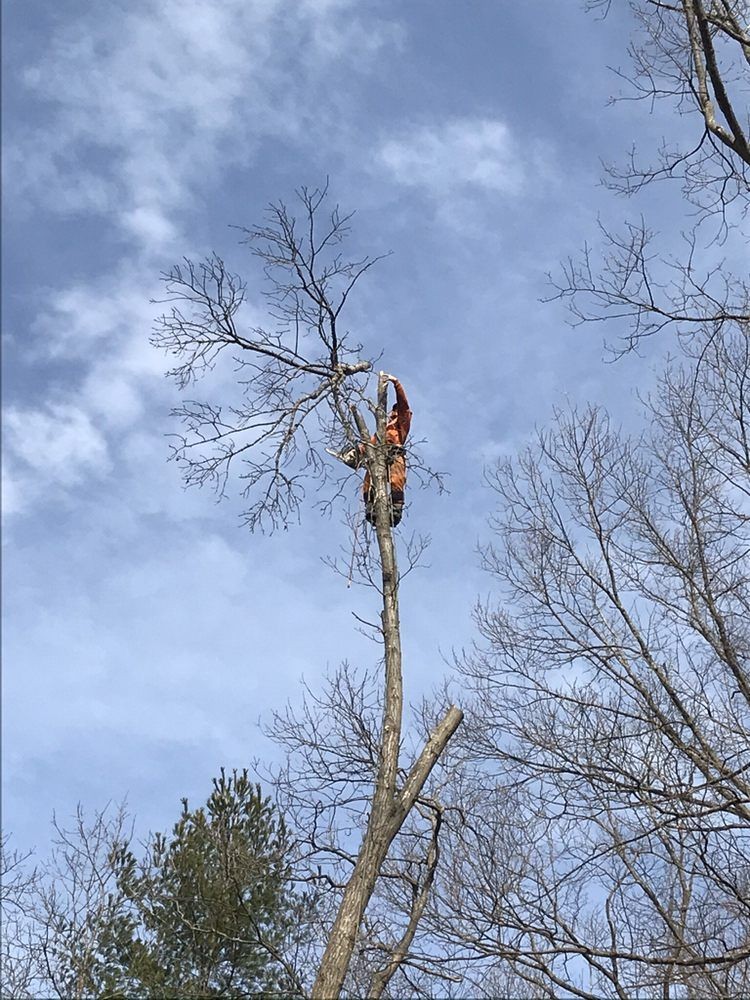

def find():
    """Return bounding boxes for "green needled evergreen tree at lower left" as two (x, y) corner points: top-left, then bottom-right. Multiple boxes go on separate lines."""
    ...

(110, 770), (299, 1000)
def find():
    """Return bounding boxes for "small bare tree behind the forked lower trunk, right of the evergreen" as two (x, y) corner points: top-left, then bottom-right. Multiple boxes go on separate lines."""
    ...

(264, 663), (464, 997)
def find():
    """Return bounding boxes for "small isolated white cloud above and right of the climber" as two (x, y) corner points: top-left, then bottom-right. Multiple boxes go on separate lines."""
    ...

(378, 118), (527, 196)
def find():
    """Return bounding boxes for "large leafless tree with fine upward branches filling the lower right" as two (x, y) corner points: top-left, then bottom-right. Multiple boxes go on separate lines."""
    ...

(414, 324), (750, 1000)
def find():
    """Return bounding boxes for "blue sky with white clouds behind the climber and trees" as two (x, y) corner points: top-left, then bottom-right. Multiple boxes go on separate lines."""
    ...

(3, 0), (680, 845)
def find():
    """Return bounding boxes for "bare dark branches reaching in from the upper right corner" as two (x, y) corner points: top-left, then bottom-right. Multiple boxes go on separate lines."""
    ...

(551, 0), (750, 353)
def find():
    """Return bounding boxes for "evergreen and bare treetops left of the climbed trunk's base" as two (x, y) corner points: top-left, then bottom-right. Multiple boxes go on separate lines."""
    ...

(2, 772), (314, 998)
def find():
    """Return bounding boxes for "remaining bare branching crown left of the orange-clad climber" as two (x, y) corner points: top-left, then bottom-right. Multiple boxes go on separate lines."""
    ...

(152, 187), (381, 529)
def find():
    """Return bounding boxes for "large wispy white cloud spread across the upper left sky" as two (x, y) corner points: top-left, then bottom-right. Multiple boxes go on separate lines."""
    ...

(5, 0), (406, 253)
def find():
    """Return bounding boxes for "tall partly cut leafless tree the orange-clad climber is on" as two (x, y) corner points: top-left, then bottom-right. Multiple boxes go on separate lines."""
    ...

(154, 188), (461, 998)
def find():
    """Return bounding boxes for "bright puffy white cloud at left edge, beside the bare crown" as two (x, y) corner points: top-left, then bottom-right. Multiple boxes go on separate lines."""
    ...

(3, 268), (164, 517)
